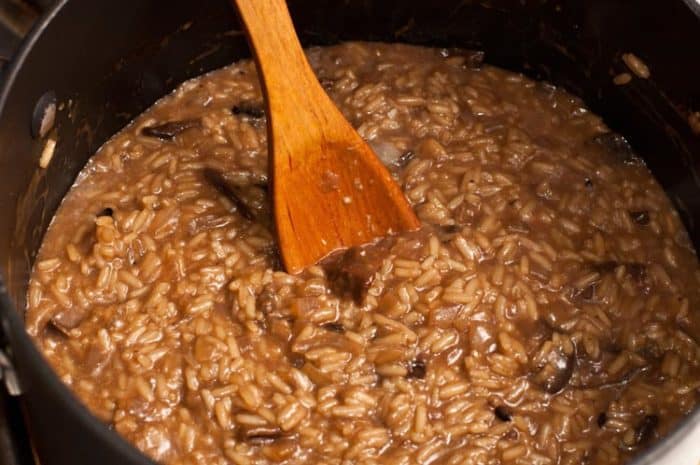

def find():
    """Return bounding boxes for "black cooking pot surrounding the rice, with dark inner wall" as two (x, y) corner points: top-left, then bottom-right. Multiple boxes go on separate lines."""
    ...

(0, 0), (700, 465)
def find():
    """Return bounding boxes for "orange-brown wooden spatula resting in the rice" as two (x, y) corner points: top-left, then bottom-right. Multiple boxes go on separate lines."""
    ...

(233, 0), (420, 273)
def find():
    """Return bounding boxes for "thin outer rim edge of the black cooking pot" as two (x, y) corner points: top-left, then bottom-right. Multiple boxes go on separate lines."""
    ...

(0, 0), (700, 465)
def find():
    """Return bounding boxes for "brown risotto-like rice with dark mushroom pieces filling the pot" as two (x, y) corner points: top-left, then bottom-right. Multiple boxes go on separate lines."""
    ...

(27, 43), (700, 465)
